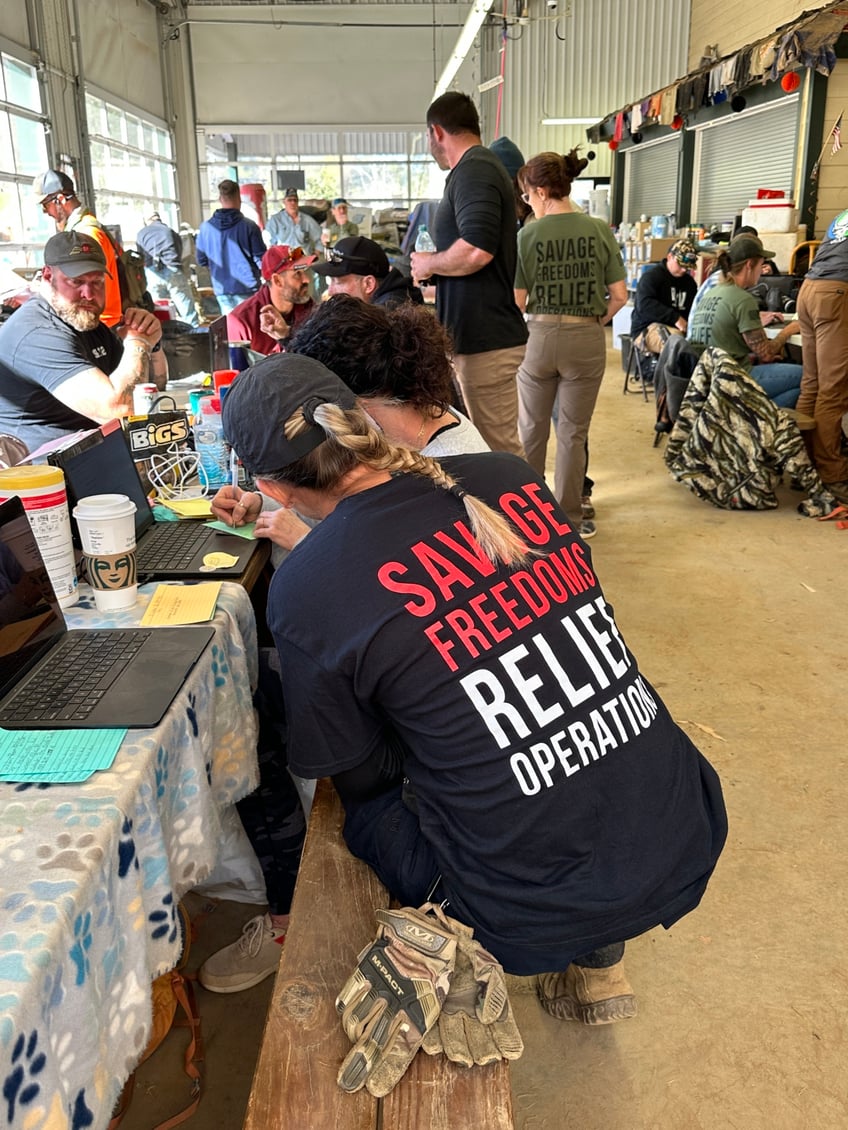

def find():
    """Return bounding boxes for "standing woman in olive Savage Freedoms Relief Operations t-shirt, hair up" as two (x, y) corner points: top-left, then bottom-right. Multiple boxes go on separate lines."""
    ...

(516, 149), (628, 538)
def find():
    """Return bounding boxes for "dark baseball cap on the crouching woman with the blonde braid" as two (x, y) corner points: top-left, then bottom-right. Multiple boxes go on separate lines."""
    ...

(222, 354), (356, 478)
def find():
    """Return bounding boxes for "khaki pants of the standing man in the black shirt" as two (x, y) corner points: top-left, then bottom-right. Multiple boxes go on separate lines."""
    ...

(453, 346), (525, 458)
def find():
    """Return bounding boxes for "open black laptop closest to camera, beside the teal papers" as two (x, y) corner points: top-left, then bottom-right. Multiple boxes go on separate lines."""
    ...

(0, 496), (215, 730)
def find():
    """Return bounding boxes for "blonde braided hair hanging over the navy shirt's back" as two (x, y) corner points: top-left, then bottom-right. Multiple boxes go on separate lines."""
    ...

(262, 403), (530, 565)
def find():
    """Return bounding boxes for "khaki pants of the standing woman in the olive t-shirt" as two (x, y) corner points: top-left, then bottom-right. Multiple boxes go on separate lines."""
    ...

(518, 321), (606, 528)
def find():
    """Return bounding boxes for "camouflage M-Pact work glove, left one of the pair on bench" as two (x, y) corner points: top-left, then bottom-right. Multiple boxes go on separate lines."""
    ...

(336, 903), (457, 1098)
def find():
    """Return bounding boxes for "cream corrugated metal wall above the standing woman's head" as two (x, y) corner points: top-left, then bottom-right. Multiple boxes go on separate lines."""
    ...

(479, 0), (690, 176)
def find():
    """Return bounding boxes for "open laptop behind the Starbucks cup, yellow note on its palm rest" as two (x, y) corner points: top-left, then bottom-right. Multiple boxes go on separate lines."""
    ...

(47, 420), (262, 582)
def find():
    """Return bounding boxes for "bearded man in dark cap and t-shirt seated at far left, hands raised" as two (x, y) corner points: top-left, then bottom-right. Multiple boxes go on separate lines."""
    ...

(0, 232), (167, 452)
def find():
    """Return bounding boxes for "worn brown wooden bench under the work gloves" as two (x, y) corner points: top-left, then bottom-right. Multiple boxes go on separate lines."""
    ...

(244, 780), (513, 1130)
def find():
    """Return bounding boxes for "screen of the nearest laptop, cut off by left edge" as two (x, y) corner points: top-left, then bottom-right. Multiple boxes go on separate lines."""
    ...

(0, 496), (66, 697)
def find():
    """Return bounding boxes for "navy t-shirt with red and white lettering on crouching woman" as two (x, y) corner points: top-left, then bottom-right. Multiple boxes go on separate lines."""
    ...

(268, 453), (727, 973)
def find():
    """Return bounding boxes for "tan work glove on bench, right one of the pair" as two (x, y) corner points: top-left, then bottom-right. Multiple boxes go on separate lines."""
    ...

(422, 909), (525, 1067)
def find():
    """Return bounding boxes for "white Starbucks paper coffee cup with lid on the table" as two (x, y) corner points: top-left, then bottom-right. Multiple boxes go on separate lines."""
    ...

(73, 495), (138, 612)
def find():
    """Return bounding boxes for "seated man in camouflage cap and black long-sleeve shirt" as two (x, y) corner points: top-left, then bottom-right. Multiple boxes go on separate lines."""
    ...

(630, 240), (698, 354)
